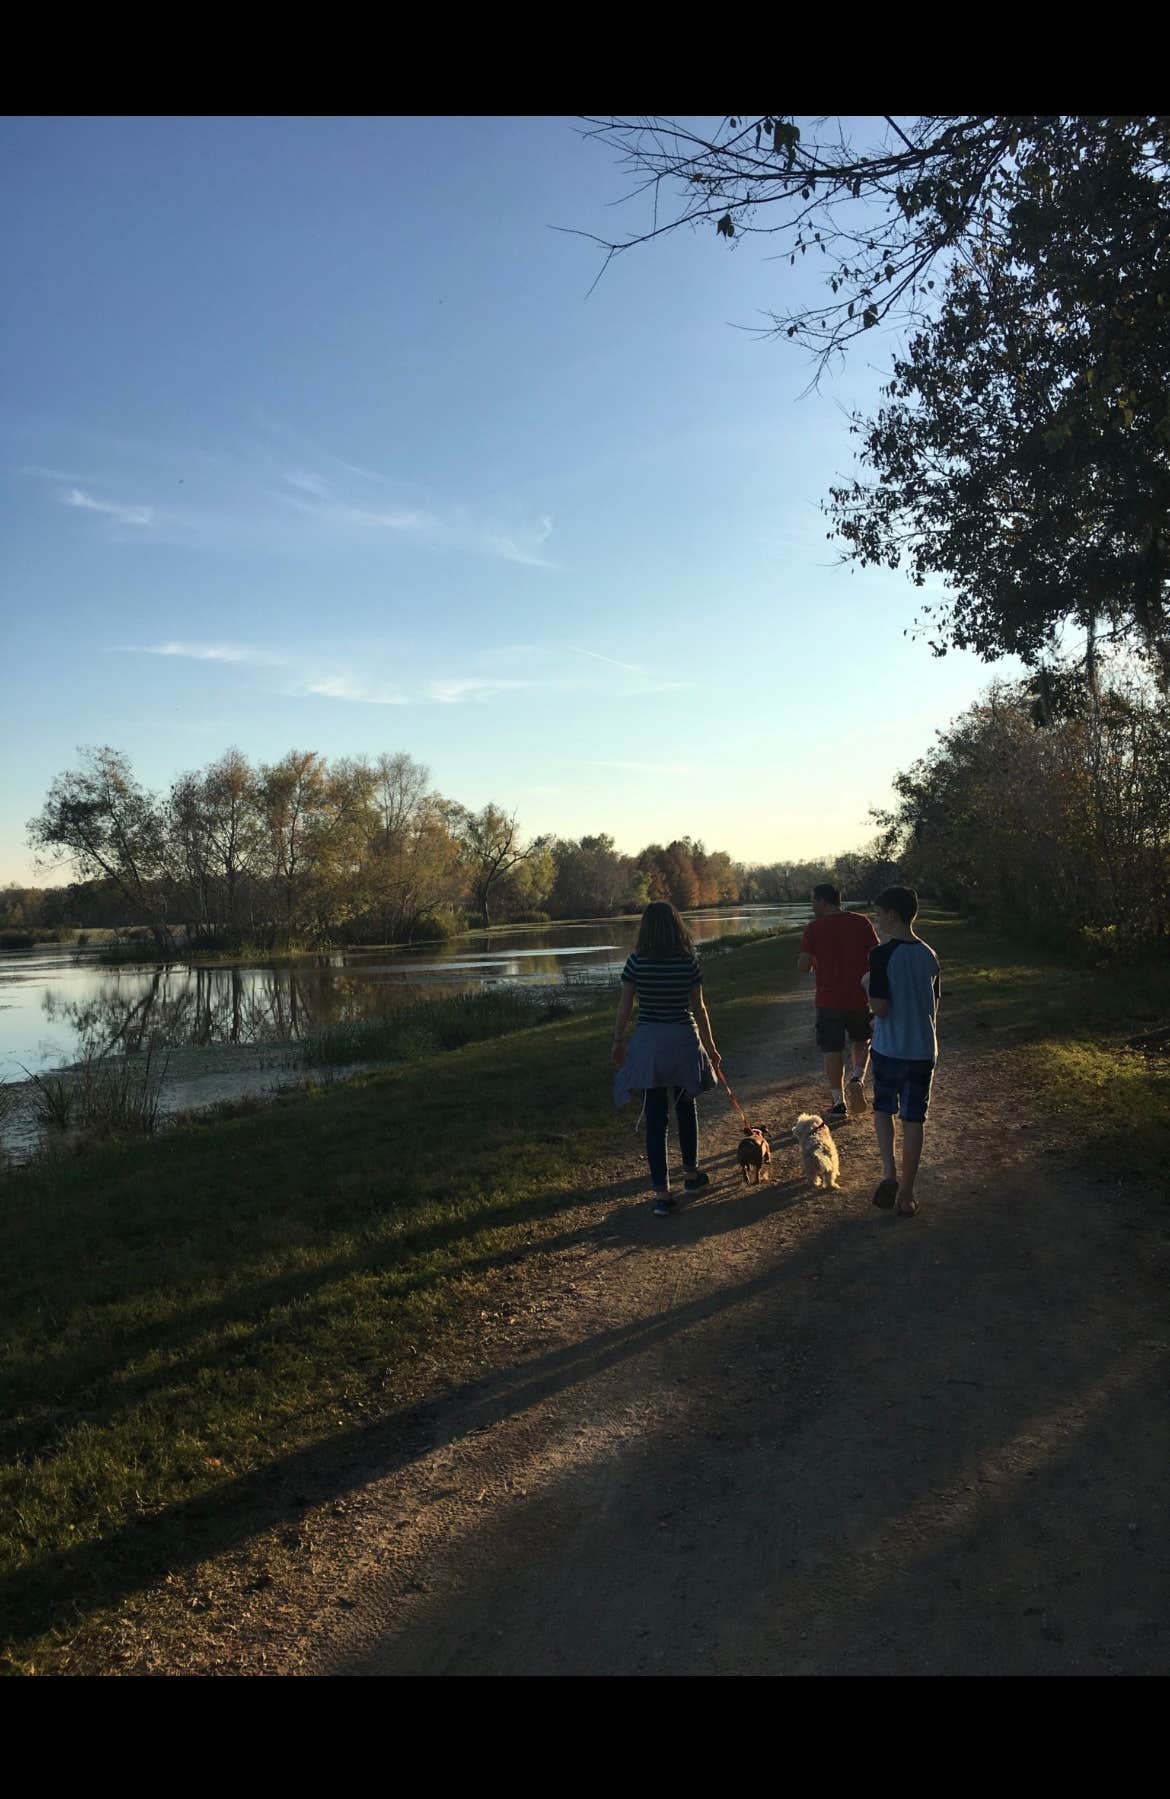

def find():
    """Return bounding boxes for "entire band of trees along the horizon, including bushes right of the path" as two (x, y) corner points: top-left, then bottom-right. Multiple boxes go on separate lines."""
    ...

(0, 664), (1170, 959)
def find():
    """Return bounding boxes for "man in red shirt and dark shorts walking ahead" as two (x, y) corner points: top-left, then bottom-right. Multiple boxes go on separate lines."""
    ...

(796, 882), (878, 1124)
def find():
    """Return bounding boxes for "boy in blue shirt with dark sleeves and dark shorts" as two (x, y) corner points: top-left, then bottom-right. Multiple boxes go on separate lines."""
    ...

(856, 887), (940, 1218)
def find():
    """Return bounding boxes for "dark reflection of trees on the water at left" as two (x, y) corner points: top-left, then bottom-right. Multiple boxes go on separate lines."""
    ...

(41, 968), (477, 1054)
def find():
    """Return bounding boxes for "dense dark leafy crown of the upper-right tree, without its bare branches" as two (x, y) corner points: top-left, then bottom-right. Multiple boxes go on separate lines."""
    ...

(830, 122), (1170, 687)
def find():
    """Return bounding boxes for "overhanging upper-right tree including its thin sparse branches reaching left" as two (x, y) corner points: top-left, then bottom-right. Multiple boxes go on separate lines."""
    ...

(585, 113), (1170, 687)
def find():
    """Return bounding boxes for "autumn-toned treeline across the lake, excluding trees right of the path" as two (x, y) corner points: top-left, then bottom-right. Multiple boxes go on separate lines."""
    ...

(9, 748), (893, 955)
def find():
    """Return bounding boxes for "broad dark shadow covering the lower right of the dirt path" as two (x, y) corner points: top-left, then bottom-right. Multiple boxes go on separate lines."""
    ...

(322, 1144), (1170, 1675)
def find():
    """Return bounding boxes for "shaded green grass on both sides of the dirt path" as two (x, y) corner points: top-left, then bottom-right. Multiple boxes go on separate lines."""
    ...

(0, 919), (1170, 1671)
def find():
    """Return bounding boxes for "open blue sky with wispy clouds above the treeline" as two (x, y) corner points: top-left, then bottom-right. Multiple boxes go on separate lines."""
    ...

(0, 117), (992, 885)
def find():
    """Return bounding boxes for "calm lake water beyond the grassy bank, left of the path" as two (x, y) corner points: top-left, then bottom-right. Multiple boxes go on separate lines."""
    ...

(0, 905), (808, 1079)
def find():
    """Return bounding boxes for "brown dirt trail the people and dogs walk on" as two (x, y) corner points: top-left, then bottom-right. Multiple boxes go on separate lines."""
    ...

(116, 993), (1170, 1675)
